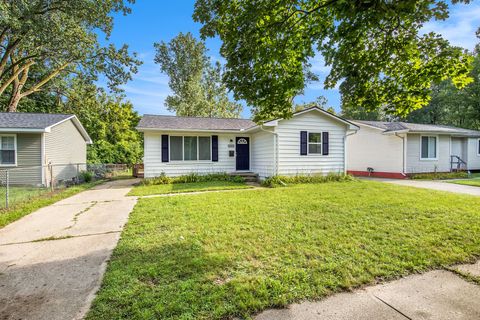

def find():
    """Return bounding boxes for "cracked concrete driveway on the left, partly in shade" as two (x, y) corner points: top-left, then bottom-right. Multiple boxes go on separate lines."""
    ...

(0, 180), (137, 320)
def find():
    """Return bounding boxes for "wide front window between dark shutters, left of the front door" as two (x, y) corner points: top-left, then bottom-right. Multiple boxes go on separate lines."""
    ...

(170, 136), (212, 161)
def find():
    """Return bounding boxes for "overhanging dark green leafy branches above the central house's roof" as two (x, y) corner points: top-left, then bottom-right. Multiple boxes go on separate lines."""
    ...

(194, 0), (471, 120)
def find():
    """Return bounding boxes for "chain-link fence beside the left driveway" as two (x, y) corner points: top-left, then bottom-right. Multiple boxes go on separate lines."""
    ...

(0, 163), (132, 210)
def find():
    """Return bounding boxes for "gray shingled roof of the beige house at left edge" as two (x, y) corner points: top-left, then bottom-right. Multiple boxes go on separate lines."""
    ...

(0, 112), (72, 129)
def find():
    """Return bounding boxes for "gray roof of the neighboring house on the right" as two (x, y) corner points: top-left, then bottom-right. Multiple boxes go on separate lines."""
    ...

(354, 120), (480, 137)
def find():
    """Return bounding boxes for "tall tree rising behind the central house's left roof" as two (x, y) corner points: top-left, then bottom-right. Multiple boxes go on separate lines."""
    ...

(155, 33), (242, 118)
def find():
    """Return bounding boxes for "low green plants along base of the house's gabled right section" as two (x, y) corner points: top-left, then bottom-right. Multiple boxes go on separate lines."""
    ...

(262, 173), (355, 188)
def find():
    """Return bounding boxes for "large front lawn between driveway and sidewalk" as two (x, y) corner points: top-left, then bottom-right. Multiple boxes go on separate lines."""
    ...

(87, 181), (480, 320)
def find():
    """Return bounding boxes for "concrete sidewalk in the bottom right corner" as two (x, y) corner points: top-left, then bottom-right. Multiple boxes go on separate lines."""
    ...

(255, 262), (480, 320)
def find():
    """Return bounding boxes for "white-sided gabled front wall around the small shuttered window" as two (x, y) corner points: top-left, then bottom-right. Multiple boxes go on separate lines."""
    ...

(275, 111), (347, 175)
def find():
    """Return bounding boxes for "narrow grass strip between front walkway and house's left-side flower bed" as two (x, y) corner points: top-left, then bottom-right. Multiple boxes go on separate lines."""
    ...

(128, 181), (251, 196)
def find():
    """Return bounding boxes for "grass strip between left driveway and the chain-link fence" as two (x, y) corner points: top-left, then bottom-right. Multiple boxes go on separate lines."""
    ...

(0, 180), (104, 228)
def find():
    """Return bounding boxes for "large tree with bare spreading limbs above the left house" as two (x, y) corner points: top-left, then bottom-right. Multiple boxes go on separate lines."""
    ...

(0, 0), (140, 112)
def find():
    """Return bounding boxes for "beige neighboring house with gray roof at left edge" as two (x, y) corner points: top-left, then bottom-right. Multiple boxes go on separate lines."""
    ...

(0, 112), (92, 186)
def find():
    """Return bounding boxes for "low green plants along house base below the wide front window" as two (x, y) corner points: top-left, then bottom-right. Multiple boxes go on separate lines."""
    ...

(142, 172), (245, 186)
